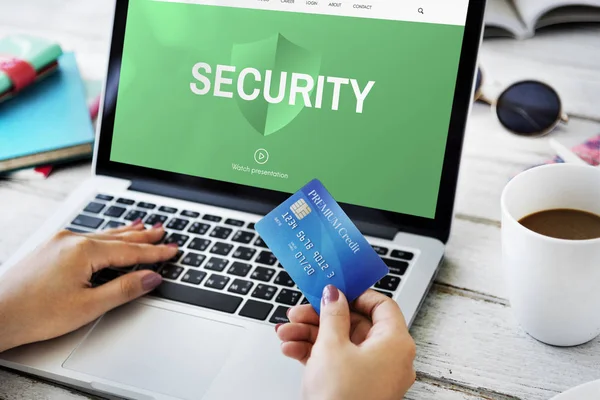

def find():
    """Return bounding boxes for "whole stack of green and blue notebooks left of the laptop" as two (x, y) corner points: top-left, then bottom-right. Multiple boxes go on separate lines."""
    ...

(0, 36), (97, 174)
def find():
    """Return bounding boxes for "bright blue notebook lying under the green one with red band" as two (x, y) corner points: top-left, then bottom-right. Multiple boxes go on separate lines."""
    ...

(0, 53), (94, 173)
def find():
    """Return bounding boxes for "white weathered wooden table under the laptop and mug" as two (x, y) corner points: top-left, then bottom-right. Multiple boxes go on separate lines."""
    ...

(0, 0), (600, 400)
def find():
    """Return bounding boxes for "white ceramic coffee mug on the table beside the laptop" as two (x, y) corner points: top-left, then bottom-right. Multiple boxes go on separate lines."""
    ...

(501, 164), (600, 346)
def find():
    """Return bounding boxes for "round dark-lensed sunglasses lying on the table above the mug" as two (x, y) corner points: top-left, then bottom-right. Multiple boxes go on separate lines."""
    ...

(475, 68), (569, 137)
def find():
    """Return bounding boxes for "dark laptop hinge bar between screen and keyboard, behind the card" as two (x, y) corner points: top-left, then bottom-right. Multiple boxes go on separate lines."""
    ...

(129, 179), (398, 240)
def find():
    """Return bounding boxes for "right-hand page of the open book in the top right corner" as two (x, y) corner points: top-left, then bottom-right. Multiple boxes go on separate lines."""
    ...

(514, 0), (600, 33)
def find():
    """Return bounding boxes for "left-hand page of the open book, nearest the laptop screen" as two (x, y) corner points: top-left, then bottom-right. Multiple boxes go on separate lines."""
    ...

(485, 0), (526, 38)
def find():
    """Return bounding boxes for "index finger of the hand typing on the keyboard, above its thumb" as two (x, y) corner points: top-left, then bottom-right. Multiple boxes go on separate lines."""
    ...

(86, 240), (177, 272)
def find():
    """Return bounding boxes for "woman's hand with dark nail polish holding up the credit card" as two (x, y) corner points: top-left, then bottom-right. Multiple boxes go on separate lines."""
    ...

(276, 286), (415, 400)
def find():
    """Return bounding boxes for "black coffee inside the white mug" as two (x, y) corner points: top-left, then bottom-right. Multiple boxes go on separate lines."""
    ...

(519, 208), (600, 240)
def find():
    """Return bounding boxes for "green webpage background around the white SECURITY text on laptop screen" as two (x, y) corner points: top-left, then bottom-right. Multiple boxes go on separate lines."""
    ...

(111, 0), (464, 218)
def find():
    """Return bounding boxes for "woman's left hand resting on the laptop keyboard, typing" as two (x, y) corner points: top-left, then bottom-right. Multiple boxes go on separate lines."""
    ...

(0, 221), (177, 352)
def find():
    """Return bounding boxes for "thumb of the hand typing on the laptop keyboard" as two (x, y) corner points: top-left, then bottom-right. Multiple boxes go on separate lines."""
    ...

(88, 271), (162, 316)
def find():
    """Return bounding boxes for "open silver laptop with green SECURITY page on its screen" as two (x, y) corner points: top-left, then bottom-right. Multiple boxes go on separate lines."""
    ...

(0, 0), (484, 400)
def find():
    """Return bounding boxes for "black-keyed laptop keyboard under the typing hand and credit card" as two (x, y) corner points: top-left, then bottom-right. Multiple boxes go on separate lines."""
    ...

(67, 194), (415, 324)
